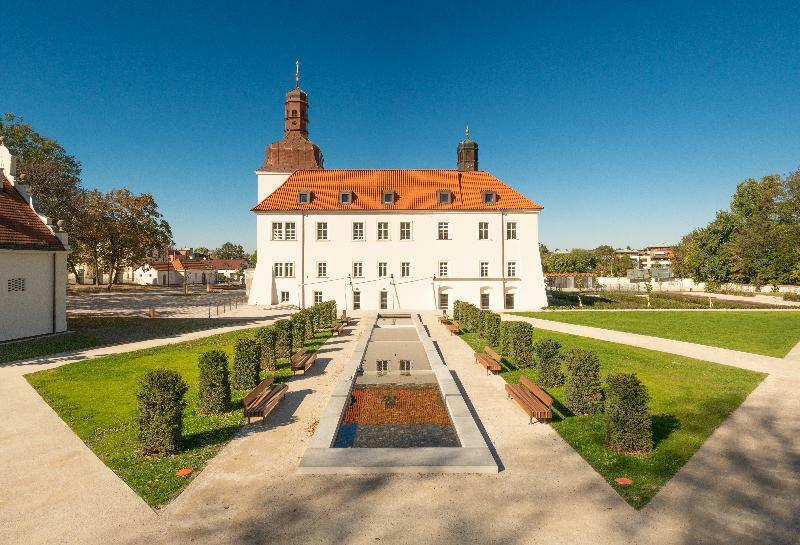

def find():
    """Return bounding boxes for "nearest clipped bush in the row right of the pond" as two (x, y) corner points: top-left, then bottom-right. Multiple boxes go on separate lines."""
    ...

(605, 373), (653, 454)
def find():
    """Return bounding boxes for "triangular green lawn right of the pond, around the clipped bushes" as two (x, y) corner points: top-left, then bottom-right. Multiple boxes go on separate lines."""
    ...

(462, 330), (766, 509)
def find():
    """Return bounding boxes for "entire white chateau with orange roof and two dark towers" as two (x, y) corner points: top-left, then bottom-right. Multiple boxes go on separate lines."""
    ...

(250, 74), (547, 310)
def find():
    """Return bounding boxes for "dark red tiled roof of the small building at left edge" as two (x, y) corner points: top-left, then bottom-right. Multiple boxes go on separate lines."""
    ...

(0, 173), (64, 251)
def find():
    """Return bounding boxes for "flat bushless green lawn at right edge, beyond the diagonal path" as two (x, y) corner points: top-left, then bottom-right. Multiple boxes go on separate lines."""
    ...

(517, 311), (800, 358)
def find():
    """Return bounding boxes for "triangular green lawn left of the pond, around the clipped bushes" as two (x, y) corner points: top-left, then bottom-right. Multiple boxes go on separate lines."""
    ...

(27, 330), (330, 507)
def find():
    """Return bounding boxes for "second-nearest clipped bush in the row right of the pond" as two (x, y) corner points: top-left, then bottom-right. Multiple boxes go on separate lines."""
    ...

(564, 349), (603, 414)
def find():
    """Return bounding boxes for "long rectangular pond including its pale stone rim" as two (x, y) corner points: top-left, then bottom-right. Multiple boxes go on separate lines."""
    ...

(298, 314), (497, 473)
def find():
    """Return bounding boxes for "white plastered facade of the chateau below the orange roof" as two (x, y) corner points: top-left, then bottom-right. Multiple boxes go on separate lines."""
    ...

(250, 209), (547, 310)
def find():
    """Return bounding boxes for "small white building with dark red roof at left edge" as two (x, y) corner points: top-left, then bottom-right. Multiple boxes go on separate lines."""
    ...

(0, 137), (69, 341)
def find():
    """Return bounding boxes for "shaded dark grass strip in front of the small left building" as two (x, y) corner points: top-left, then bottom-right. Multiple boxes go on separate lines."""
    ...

(0, 316), (241, 363)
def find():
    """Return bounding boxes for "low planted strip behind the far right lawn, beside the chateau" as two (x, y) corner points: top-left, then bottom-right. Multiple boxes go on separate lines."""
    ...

(547, 290), (792, 310)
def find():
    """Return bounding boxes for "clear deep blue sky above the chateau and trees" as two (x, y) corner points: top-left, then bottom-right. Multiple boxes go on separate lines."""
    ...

(6, 1), (800, 249)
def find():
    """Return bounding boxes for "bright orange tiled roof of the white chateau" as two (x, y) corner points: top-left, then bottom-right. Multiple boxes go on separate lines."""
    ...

(253, 170), (542, 212)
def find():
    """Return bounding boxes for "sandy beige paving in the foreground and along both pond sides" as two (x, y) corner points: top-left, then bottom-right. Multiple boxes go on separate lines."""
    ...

(0, 313), (800, 545)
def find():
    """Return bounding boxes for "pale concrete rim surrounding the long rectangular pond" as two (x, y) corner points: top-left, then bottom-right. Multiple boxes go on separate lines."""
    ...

(297, 314), (498, 474)
